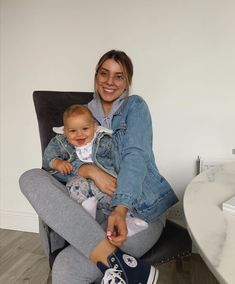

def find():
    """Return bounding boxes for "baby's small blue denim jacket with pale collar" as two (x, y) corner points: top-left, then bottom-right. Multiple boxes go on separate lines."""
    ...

(43, 127), (118, 182)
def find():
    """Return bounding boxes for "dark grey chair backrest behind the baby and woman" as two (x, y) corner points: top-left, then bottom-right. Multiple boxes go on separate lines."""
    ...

(33, 91), (93, 153)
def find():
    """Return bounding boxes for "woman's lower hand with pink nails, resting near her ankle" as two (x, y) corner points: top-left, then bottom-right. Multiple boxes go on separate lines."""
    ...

(107, 205), (128, 247)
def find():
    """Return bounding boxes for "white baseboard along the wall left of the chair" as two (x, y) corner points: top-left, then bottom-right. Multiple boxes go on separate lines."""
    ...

(0, 209), (39, 233)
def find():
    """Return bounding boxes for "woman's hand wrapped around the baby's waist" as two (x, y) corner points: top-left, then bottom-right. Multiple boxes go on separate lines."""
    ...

(78, 164), (117, 196)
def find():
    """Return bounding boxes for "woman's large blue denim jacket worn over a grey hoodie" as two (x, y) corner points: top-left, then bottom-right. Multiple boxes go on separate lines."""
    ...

(88, 95), (178, 222)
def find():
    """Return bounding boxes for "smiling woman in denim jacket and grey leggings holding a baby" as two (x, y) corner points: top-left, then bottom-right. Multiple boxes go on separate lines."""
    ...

(20, 50), (177, 284)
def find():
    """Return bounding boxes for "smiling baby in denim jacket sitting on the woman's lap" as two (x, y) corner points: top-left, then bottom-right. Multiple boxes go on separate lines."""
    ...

(43, 105), (148, 236)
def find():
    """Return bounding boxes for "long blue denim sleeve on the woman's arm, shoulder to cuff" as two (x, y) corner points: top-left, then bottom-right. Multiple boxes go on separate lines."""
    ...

(112, 96), (157, 209)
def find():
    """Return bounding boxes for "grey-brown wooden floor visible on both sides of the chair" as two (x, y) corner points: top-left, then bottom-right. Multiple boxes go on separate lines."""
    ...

(0, 229), (218, 284)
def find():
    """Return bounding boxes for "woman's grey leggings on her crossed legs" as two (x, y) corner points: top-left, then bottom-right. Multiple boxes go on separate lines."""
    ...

(20, 169), (164, 284)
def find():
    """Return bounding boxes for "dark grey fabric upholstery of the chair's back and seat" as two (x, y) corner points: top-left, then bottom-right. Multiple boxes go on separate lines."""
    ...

(33, 91), (192, 267)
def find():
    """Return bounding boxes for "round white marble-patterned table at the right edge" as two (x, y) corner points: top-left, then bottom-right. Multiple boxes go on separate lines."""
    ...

(183, 162), (235, 284)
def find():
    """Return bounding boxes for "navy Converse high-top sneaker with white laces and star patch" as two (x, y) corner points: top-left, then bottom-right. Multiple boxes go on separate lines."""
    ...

(97, 249), (158, 284)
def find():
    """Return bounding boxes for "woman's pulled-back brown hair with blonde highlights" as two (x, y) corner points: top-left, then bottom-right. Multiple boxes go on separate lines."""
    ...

(95, 49), (133, 93)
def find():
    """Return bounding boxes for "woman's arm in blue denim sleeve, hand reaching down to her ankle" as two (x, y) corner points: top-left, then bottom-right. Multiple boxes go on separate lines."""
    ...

(107, 96), (152, 246)
